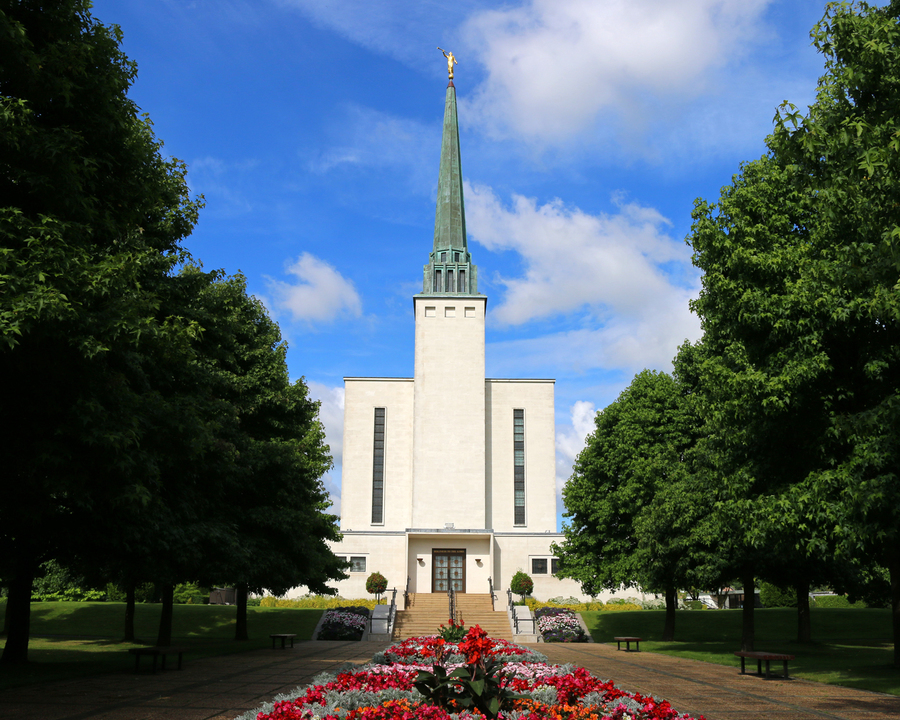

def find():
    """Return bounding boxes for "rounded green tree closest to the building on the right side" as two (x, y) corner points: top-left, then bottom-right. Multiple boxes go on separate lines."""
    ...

(553, 358), (705, 640)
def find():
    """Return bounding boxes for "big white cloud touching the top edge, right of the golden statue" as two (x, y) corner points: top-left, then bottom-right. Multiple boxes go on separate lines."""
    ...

(464, 0), (771, 141)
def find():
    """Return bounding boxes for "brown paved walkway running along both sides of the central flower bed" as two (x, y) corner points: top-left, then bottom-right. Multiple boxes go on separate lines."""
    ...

(0, 642), (900, 720)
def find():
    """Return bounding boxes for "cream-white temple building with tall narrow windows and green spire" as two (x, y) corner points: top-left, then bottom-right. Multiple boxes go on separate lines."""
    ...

(318, 80), (583, 599)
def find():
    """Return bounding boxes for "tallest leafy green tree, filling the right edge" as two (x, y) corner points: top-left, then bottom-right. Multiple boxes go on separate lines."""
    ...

(690, 0), (900, 664)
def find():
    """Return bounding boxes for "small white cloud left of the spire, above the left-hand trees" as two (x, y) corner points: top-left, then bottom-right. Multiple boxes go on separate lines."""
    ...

(266, 252), (362, 322)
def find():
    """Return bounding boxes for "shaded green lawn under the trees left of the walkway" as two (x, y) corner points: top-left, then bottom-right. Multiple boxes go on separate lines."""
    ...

(0, 602), (323, 690)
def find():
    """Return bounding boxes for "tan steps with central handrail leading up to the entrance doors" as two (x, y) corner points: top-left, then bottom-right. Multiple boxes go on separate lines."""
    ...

(394, 593), (512, 641)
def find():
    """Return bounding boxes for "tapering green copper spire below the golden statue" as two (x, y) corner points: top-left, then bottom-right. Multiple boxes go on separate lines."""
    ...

(423, 80), (478, 295)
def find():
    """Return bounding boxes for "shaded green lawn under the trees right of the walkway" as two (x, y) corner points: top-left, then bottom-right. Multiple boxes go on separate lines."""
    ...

(581, 608), (900, 695)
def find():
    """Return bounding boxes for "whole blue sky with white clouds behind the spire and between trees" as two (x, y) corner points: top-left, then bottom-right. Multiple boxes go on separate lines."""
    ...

(93, 0), (836, 528)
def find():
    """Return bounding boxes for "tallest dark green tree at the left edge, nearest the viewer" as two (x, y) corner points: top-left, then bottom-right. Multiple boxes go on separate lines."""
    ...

(0, 0), (198, 662)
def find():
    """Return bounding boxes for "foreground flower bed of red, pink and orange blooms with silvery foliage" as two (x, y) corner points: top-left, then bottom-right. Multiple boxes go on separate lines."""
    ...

(244, 626), (703, 720)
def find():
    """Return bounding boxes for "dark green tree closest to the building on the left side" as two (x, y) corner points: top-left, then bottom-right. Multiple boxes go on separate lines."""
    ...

(182, 267), (346, 639)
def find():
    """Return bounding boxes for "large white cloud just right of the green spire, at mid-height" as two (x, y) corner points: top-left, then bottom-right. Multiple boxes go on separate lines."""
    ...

(465, 185), (699, 330)
